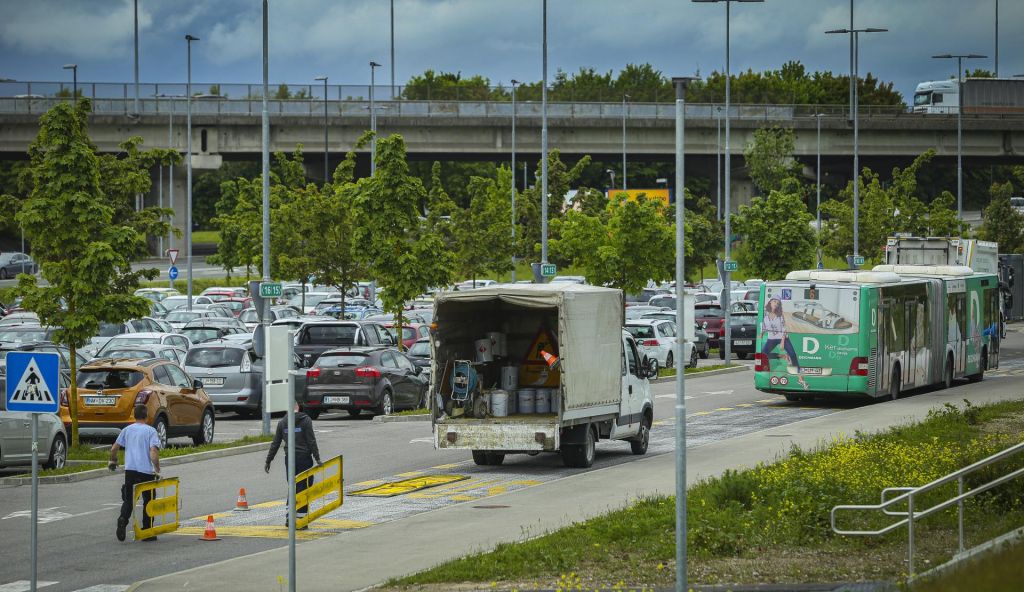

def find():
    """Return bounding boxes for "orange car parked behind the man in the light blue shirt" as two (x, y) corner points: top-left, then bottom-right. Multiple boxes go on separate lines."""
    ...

(60, 358), (214, 447)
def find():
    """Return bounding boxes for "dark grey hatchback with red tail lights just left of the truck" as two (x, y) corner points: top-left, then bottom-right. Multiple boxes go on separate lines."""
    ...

(300, 347), (428, 419)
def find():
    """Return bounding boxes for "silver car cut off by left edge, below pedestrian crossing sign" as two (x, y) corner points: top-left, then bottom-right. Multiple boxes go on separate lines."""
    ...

(0, 387), (71, 469)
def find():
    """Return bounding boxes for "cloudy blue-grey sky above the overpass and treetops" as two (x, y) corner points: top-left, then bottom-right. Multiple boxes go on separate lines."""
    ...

(0, 0), (1024, 101)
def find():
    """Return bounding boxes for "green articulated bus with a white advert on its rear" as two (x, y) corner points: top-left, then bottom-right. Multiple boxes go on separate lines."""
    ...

(754, 265), (999, 400)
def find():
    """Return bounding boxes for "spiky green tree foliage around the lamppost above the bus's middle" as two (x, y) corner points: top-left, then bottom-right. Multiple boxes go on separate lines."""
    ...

(821, 151), (970, 261)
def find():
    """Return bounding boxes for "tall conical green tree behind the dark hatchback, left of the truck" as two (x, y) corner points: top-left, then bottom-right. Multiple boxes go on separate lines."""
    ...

(355, 135), (455, 335)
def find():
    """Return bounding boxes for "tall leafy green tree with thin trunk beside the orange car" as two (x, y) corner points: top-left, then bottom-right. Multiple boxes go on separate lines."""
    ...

(17, 99), (157, 446)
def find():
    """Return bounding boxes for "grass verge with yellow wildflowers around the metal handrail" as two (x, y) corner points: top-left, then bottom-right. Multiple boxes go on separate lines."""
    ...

(387, 401), (1024, 590)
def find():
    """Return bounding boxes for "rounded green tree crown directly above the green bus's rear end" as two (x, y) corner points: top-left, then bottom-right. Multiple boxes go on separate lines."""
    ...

(733, 183), (817, 280)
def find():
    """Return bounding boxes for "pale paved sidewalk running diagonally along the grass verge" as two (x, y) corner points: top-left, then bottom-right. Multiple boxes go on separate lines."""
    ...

(131, 379), (1021, 592)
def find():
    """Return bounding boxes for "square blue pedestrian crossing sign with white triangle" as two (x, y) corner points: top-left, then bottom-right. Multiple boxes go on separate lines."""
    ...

(6, 351), (60, 413)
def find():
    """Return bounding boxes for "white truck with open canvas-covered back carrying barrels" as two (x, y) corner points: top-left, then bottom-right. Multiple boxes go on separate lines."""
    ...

(431, 283), (654, 467)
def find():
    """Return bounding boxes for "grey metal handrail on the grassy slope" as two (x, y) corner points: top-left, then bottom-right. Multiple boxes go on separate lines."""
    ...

(831, 442), (1024, 576)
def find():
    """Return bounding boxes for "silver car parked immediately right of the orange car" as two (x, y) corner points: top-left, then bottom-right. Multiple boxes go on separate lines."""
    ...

(184, 339), (263, 417)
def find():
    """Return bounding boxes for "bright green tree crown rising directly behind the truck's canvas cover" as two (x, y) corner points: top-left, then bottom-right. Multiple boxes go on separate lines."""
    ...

(551, 195), (676, 293)
